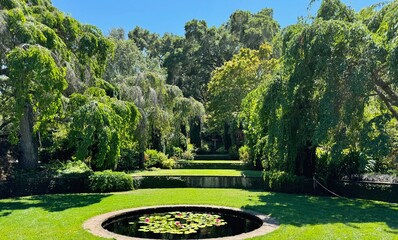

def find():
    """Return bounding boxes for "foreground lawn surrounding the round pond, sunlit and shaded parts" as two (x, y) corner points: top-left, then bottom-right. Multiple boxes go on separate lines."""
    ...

(0, 188), (398, 240)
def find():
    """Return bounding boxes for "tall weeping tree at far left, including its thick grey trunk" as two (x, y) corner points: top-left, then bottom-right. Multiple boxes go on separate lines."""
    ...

(0, 0), (112, 168)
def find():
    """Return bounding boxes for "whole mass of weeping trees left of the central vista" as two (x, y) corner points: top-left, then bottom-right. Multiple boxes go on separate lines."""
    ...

(0, 0), (204, 170)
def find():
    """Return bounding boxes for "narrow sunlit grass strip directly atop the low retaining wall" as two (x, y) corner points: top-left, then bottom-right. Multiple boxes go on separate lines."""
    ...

(132, 169), (262, 177)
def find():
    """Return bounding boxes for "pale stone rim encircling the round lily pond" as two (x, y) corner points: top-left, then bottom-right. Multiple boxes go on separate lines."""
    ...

(83, 205), (279, 240)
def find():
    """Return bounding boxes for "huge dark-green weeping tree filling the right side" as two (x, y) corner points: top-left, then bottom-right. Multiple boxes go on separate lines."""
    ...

(242, 0), (397, 176)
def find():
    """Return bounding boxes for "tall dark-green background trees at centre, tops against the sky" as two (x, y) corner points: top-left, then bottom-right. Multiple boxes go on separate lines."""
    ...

(128, 9), (280, 103)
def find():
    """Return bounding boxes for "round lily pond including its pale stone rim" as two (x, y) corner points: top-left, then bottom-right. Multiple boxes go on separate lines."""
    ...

(84, 205), (278, 240)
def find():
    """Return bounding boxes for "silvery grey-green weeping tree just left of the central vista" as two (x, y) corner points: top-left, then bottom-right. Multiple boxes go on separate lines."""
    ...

(104, 34), (204, 165)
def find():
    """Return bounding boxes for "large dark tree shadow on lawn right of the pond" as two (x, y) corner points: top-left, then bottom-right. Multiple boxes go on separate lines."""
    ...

(244, 193), (398, 231)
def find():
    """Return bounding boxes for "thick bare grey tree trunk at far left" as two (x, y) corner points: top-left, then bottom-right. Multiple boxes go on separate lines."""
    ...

(19, 103), (39, 169)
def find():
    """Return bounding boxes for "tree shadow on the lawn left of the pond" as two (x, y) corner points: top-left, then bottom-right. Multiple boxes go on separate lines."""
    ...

(0, 194), (110, 217)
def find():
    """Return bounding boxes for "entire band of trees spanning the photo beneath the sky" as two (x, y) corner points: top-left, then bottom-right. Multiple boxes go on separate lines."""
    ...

(0, 0), (398, 186)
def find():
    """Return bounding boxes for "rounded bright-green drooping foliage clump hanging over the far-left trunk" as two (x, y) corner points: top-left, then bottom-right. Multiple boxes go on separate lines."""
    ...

(7, 45), (67, 133)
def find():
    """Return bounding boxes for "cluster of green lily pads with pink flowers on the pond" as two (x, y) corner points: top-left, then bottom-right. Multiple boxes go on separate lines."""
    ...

(133, 212), (227, 234)
